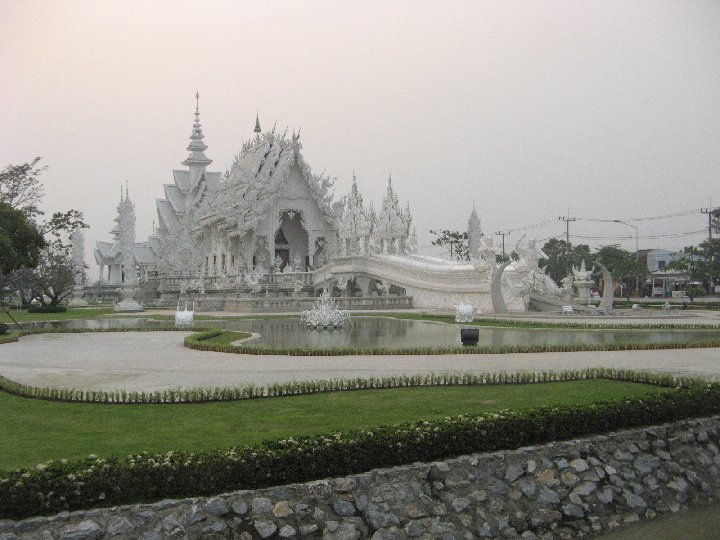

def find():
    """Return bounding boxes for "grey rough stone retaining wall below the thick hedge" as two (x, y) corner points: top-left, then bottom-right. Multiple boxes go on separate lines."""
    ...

(0, 417), (720, 540)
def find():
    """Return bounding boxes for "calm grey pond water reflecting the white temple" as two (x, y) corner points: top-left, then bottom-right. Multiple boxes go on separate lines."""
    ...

(24, 317), (717, 349)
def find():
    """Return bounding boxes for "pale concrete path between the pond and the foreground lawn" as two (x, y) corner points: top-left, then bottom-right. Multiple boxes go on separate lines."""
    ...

(0, 332), (720, 390)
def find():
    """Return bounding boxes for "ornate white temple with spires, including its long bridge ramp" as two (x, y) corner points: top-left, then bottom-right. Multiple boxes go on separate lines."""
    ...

(90, 95), (584, 312)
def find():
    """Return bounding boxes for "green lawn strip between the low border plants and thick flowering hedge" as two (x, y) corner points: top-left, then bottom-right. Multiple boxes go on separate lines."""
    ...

(0, 379), (673, 470)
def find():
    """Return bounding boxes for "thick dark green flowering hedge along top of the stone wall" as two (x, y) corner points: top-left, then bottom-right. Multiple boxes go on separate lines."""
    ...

(0, 384), (720, 519)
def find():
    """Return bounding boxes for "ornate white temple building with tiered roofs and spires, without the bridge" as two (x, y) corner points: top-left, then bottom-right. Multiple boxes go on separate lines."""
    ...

(95, 96), (414, 284)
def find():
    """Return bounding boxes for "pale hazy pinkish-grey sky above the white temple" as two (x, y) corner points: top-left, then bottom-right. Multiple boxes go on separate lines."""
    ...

(0, 0), (720, 262)
